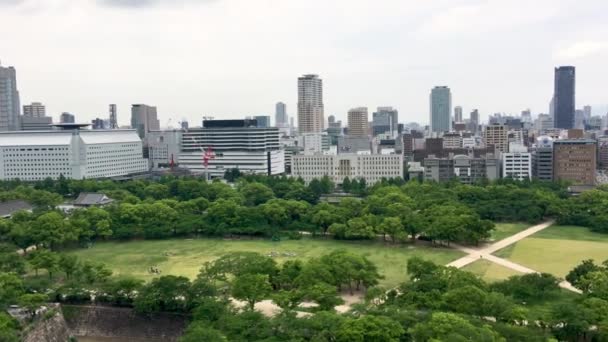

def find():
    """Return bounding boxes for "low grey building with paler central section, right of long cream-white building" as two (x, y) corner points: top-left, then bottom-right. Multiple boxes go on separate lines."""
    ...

(424, 155), (500, 184)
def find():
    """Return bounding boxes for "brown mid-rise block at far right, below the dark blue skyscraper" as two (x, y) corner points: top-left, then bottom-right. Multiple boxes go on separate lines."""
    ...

(553, 139), (597, 185)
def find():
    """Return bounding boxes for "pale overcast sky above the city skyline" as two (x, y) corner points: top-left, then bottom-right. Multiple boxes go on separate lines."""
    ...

(0, 0), (608, 126)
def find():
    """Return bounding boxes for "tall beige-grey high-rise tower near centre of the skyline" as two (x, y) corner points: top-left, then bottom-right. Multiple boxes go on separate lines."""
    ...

(298, 75), (325, 133)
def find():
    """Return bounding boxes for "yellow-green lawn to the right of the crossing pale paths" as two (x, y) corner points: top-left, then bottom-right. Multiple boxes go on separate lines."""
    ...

(495, 226), (608, 277)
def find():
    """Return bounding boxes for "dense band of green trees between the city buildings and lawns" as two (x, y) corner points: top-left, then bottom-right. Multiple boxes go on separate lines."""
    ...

(0, 175), (588, 249)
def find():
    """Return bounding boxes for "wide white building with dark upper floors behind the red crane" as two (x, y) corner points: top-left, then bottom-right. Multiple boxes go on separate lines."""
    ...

(179, 120), (285, 178)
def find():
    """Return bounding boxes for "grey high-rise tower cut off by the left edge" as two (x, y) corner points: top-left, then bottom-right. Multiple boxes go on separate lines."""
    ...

(0, 65), (21, 131)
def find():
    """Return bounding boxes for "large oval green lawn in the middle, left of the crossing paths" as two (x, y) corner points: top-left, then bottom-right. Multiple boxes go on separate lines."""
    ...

(70, 239), (464, 287)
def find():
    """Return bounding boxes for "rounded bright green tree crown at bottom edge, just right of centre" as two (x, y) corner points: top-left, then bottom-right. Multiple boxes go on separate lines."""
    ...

(336, 315), (405, 342)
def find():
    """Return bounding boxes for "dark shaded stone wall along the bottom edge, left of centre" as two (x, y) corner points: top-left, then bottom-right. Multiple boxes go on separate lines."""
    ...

(61, 305), (186, 341)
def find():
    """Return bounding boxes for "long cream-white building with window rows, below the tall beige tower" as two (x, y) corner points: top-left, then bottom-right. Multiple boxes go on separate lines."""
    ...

(292, 154), (403, 185)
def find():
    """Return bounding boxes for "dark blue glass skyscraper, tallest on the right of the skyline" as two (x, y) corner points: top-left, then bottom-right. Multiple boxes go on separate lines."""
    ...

(553, 66), (576, 129)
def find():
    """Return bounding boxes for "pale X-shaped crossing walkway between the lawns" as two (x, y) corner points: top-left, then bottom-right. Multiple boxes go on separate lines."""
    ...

(447, 221), (581, 293)
